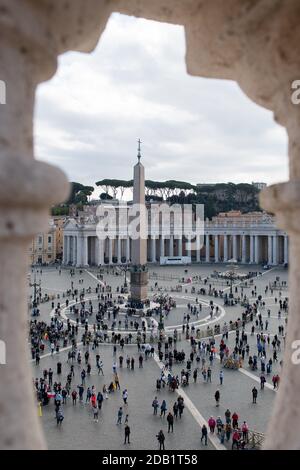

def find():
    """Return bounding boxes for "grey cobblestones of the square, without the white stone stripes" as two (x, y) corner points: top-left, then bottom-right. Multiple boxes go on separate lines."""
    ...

(28, 265), (287, 450)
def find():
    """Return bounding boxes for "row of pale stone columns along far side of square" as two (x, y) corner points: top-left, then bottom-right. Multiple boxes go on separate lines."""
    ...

(63, 233), (288, 266)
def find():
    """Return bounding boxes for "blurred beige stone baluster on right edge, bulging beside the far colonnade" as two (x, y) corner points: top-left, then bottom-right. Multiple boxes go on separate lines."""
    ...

(261, 181), (300, 450)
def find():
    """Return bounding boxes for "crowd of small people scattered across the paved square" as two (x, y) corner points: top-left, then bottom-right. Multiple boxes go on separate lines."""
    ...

(29, 266), (288, 449)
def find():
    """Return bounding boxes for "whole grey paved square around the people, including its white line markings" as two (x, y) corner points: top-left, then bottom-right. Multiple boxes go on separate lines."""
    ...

(29, 265), (288, 450)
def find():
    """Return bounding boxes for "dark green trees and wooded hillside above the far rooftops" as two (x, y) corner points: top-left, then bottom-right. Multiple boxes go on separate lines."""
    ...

(52, 179), (261, 219)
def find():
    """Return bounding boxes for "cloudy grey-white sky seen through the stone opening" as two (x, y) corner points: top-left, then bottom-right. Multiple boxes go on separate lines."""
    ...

(35, 14), (288, 194)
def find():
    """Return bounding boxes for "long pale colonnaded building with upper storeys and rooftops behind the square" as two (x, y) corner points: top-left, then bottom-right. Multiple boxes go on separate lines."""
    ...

(63, 207), (288, 266)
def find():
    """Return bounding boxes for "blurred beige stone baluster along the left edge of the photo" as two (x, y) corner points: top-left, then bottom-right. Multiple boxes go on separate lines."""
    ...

(0, 8), (68, 450)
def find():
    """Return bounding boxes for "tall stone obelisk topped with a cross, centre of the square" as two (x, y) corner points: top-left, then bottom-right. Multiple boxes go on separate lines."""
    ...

(130, 139), (148, 309)
